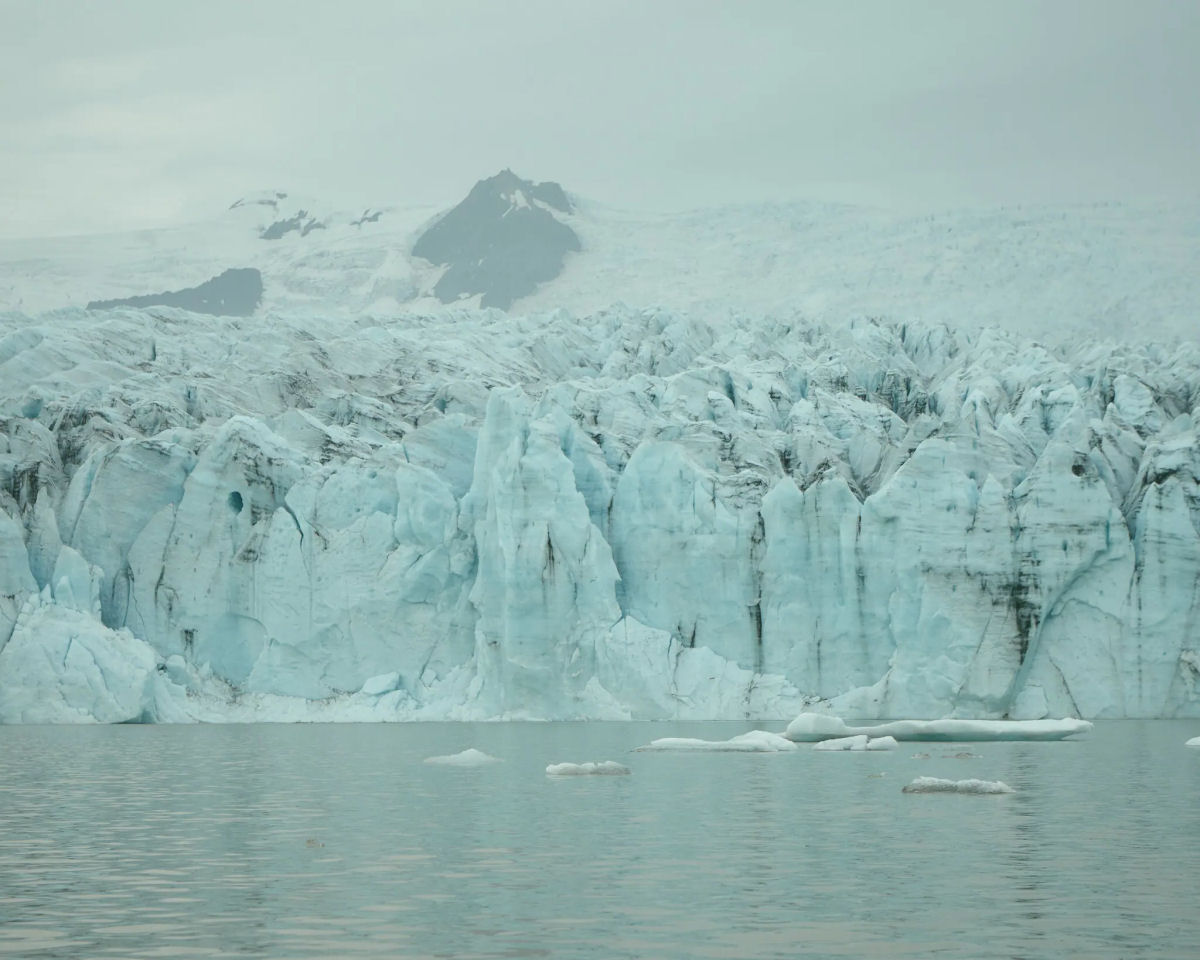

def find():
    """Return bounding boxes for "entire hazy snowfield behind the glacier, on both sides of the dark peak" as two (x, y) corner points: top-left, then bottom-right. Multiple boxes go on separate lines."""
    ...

(0, 186), (1200, 343)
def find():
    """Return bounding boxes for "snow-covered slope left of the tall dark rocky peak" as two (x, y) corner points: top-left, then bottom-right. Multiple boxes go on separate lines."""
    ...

(0, 191), (439, 316)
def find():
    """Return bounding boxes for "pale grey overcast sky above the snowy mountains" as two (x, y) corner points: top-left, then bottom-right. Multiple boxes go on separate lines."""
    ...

(0, 0), (1200, 236)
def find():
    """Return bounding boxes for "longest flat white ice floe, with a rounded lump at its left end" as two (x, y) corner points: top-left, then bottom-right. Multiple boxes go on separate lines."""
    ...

(784, 713), (1093, 743)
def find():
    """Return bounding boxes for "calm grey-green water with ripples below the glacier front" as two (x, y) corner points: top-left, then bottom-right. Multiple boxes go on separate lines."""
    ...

(0, 721), (1200, 960)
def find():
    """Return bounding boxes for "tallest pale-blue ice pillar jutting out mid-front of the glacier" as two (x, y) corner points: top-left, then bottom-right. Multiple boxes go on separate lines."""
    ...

(463, 389), (620, 716)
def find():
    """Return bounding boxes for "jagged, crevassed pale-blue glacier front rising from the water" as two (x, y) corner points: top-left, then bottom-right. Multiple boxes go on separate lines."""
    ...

(0, 307), (1200, 721)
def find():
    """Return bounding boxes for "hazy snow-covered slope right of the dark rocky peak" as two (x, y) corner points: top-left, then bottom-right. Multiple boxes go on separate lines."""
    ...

(517, 202), (1200, 343)
